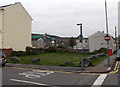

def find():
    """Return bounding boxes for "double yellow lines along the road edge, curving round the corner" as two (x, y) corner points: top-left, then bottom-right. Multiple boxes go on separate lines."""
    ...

(5, 61), (120, 75)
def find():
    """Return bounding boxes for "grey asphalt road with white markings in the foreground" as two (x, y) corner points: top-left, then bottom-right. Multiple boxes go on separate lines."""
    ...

(2, 62), (120, 87)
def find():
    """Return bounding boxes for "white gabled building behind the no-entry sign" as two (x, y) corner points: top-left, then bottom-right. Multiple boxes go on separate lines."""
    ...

(88, 31), (116, 52)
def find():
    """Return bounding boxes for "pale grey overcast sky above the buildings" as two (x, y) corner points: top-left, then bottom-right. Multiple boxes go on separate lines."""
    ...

(0, 0), (119, 37)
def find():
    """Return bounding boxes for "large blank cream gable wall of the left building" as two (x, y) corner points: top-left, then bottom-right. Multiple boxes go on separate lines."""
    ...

(0, 3), (32, 51)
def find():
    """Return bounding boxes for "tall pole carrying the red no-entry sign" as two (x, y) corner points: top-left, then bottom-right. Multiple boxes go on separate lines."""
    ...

(105, 0), (110, 67)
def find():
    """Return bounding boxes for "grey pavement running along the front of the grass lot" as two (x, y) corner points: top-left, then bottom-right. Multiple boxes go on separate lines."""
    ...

(6, 55), (116, 73)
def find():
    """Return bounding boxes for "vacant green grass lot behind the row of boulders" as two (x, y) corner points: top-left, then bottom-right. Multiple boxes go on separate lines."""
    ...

(8, 53), (106, 67)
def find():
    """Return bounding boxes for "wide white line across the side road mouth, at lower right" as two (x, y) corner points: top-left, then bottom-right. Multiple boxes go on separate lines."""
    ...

(91, 74), (107, 87)
